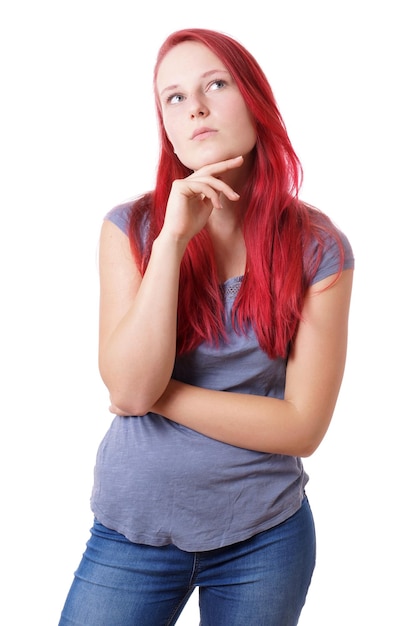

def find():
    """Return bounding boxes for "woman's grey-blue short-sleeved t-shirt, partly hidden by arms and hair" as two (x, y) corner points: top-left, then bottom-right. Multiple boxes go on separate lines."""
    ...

(91, 203), (354, 552)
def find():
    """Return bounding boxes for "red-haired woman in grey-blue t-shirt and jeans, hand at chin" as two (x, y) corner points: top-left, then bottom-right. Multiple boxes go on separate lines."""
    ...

(60, 29), (354, 626)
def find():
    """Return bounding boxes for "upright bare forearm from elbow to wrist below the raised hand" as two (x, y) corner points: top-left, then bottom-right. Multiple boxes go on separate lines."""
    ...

(100, 236), (183, 414)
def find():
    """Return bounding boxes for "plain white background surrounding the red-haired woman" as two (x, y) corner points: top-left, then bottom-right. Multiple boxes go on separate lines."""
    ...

(0, 0), (417, 626)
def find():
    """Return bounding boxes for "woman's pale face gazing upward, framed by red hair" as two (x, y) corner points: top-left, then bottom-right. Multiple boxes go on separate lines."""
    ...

(156, 41), (256, 171)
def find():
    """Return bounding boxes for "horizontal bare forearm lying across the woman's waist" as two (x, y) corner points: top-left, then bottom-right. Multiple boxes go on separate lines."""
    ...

(152, 380), (332, 456)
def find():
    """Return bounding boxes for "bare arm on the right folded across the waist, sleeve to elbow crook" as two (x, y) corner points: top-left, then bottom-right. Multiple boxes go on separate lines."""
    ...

(153, 270), (353, 456)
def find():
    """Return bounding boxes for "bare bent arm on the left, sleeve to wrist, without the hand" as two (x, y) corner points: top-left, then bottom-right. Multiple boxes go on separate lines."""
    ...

(99, 221), (184, 415)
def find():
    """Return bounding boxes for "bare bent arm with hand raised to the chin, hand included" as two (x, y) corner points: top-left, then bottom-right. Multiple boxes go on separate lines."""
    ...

(99, 157), (243, 415)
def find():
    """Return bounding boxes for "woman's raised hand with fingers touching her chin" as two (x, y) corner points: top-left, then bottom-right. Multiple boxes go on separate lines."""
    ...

(162, 156), (243, 243)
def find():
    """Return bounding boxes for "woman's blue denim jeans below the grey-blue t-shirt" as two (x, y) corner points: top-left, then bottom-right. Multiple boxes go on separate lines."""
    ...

(59, 498), (315, 626)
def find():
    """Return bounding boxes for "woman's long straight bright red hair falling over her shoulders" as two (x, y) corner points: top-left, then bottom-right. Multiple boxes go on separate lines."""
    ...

(129, 28), (342, 358)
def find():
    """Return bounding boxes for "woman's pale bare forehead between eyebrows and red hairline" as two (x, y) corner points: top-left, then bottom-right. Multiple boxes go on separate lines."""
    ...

(156, 41), (226, 92)
